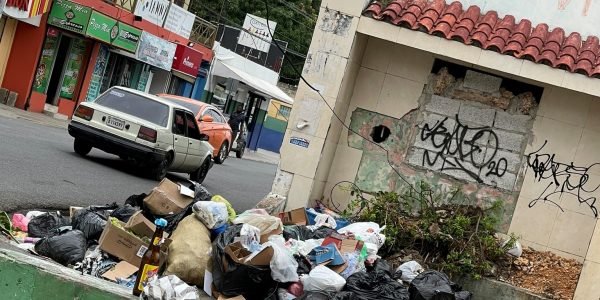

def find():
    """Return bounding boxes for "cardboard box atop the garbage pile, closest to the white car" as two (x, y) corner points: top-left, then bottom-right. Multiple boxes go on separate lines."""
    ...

(144, 178), (194, 216)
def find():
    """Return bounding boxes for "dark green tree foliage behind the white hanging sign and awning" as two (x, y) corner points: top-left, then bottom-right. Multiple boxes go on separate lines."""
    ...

(190, 0), (321, 84)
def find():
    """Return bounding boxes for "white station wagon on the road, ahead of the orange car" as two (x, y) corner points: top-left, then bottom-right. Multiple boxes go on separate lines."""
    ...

(69, 87), (213, 182)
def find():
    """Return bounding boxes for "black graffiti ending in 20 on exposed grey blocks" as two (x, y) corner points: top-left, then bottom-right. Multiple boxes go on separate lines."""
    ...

(420, 115), (508, 183)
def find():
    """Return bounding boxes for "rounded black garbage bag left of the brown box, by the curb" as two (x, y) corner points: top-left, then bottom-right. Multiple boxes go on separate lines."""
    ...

(35, 229), (87, 266)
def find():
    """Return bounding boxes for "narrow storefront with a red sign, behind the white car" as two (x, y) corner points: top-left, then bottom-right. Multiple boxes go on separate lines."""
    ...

(167, 45), (202, 98)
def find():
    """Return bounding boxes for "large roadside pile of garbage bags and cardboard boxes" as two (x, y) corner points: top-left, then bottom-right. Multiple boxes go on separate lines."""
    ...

(0, 179), (471, 300)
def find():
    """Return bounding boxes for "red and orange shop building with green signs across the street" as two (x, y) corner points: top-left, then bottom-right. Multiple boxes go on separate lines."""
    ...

(0, 0), (216, 117)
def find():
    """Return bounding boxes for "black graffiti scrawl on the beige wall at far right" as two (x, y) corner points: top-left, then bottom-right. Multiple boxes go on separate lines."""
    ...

(527, 141), (600, 217)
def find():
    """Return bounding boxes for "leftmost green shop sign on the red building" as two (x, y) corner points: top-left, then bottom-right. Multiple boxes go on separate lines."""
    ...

(48, 0), (92, 34)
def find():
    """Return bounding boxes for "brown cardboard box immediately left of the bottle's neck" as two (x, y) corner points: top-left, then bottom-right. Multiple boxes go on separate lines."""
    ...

(98, 221), (171, 266)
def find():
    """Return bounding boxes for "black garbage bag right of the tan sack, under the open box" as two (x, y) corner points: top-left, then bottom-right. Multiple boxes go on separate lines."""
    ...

(212, 224), (277, 300)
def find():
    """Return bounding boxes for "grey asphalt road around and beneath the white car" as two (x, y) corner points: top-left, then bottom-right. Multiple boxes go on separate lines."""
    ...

(0, 117), (277, 212)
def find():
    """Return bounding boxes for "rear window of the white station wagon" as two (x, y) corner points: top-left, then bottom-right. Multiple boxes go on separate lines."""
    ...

(94, 89), (169, 127)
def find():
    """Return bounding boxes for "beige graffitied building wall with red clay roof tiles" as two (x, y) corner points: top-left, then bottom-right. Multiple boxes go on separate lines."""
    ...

(273, 0), (600, 300)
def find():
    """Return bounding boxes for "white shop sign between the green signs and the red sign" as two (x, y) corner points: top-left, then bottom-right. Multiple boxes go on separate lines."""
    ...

(135, 31), (177, 71)
